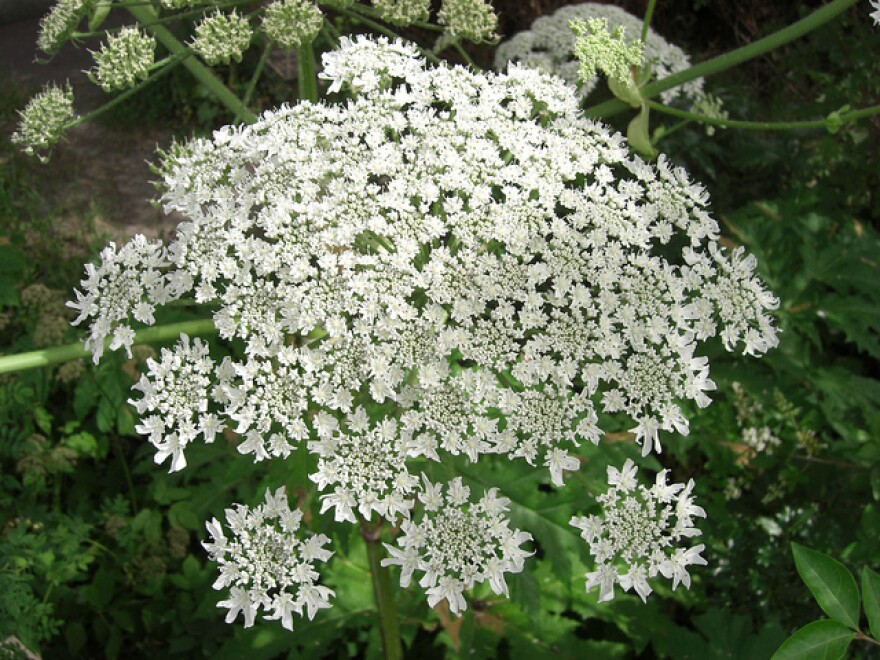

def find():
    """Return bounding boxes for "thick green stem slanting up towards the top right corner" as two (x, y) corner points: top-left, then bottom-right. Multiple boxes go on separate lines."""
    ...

(584, 0), (858, 117)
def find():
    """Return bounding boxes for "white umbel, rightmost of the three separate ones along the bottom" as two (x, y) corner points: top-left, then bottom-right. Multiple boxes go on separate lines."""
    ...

(570, 459), (706, 602)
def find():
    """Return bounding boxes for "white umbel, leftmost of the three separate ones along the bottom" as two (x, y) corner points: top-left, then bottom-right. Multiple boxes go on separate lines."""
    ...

(202, 487), (335, 630)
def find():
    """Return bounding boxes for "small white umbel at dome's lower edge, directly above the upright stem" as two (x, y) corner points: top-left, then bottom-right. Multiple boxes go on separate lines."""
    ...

(309, 408), (419, 522)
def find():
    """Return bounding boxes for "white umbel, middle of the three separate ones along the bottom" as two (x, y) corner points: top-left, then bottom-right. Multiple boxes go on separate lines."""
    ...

(382, 475), (533, 614)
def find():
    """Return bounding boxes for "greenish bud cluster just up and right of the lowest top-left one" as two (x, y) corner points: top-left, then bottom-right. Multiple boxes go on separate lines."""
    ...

(88, 27), (156, 92)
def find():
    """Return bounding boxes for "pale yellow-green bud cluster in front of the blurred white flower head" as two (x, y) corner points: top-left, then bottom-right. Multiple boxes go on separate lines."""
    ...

(569, 18), (645, 82)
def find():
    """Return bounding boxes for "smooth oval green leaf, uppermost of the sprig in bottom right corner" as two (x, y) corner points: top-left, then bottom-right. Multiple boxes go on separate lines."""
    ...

(791, 543), (859, 628)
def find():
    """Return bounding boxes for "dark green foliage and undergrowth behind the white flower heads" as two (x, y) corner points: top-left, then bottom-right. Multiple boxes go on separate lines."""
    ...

(0, 0), (880, 660)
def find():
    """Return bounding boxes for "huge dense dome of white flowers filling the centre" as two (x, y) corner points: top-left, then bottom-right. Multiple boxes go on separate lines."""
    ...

(74, 38), (776, 484)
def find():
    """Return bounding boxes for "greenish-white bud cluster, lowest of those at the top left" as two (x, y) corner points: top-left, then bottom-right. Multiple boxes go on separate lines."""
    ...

(12, 83), (76, 161)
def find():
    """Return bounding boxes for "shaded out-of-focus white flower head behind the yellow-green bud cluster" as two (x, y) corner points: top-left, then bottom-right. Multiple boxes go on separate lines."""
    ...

(495, 2), (703, 103)
